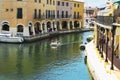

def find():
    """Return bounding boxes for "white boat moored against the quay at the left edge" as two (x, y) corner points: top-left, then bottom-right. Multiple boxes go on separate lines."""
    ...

(0, 34), (24, 43)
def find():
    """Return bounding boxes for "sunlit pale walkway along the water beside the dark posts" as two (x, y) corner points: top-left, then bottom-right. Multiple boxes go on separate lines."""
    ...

(86, 41), (120, 80)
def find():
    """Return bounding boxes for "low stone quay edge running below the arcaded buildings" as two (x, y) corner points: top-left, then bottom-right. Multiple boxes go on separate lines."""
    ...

(23, 28), (94, 43)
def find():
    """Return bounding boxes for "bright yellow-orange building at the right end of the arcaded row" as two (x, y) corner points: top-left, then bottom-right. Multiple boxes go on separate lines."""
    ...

(72, 1), (84, 28)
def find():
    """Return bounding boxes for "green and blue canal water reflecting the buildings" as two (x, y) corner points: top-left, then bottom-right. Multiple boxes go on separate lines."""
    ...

(0, 32), (93, 80)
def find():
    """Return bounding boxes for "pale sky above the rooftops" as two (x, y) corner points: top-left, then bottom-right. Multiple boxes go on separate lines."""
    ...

(75, 0), (108, 7)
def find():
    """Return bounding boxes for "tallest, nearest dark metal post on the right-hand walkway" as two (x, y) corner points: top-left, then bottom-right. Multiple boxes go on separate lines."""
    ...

(111, 25), (116, 70)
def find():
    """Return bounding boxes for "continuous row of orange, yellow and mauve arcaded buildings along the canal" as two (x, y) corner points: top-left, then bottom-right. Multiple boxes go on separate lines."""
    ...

(0, 0), (84, 36)
